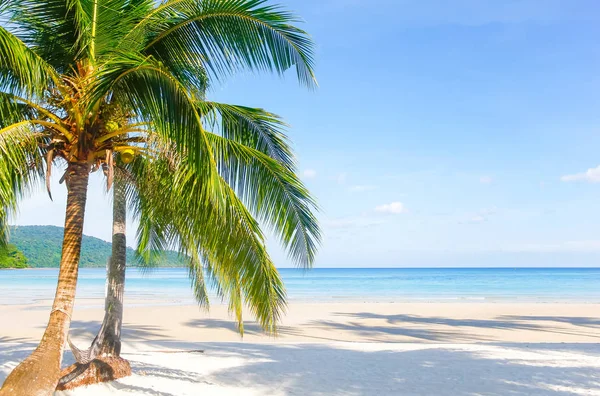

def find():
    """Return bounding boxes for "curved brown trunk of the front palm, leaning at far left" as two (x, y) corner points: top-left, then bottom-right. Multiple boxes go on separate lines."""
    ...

(0, 162), (89, 396)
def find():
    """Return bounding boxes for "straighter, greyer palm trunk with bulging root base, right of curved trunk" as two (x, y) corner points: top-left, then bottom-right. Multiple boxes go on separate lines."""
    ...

(56, 177), (131, 390)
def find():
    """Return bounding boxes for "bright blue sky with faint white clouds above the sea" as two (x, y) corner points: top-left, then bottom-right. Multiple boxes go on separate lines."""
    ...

(14, 0), (600, 267)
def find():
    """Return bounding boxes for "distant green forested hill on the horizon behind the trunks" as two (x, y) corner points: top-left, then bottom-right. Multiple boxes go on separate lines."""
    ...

(0, 226), (184, 268)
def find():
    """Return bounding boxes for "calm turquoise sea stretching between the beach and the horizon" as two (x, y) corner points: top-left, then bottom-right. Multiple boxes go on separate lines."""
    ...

(0, 268), (600, 305)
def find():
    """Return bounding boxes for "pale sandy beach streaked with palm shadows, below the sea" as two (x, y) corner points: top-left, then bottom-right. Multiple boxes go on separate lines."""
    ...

(0, 300), (600, 396)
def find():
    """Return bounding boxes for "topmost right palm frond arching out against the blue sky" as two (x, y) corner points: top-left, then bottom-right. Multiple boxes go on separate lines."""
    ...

(143, 0), (316, 87)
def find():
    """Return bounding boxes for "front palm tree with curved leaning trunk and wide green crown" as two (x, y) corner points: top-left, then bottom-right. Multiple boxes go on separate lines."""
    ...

(0, 0), (319, 395)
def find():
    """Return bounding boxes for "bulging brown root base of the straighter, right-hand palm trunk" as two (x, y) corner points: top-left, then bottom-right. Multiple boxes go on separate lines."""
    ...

(56, 356), (131, 390)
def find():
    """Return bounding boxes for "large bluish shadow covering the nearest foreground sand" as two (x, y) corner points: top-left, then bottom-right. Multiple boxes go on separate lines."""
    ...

(50, 343), (600, 396)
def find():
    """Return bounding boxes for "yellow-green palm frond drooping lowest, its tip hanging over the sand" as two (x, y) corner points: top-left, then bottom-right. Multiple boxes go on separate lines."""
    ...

(132, 153), (285, 332)
